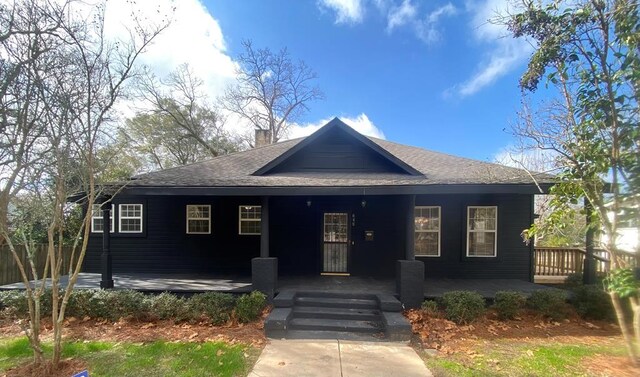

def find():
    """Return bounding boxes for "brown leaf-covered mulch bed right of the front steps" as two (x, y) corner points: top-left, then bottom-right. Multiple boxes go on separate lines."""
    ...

(405, 310), (620, 353)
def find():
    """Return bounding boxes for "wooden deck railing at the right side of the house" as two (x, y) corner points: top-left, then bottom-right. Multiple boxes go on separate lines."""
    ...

(535, 247), (640, 276)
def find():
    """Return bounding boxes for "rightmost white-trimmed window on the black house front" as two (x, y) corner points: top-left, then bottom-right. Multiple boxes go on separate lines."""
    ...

(467, 206), (498, 257)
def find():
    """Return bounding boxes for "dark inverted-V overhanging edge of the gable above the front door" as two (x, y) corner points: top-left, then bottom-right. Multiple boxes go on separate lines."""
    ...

(253, 118), (422, 175)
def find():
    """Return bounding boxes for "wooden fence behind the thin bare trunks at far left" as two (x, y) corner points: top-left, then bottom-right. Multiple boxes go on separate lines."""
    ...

(0, 245), (71, 285)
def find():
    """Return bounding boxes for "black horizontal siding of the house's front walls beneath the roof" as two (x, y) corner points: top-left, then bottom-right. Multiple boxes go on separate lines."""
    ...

(84, 195), (531, 280)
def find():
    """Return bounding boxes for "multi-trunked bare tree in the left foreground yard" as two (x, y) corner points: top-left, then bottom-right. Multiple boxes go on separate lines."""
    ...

(0, 0), (167, 368)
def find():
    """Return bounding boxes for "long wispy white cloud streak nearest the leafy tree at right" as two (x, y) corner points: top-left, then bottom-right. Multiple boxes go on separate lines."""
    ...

(445, 0), (533, 97)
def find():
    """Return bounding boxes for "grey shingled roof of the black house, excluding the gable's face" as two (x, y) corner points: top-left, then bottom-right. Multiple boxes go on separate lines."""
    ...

(127, 119), (554, 195)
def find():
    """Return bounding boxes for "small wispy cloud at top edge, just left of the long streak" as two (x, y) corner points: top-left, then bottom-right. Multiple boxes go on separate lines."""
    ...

(378, 0), (457, 45)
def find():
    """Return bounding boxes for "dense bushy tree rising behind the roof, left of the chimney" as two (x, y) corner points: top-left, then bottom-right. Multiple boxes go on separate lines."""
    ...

(133, 64), (239, 169)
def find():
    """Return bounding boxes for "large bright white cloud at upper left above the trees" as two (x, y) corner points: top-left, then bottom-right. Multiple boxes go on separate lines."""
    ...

(99, 0), (236, 120)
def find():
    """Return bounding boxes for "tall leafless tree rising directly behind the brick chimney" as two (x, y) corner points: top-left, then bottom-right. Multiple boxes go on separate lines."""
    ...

(221, 41), (324, 143)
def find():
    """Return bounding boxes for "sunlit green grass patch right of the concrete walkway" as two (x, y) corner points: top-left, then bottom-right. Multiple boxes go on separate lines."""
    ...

(426, 340), (625, 377)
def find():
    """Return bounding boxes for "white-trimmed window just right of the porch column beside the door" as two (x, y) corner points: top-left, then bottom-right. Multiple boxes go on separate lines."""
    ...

(414, 206), (440, 257)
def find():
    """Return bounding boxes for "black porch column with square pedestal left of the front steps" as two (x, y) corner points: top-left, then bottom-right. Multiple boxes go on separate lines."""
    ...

(251, 196), (278, 302)
